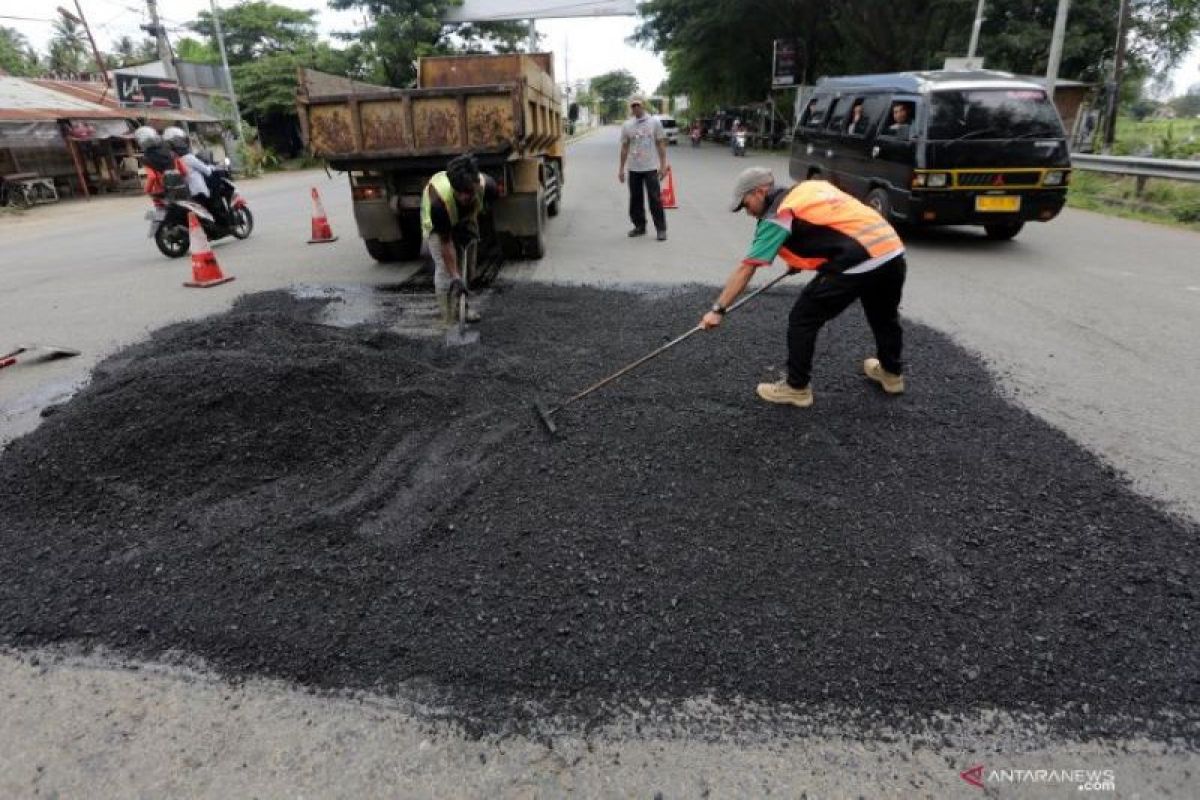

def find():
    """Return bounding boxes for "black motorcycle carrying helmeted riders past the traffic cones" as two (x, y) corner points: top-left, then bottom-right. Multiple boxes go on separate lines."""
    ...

(145, 169), (254, 258)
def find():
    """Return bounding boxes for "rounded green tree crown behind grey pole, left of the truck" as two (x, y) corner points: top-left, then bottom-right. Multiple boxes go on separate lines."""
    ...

(188, 0), (317, 65)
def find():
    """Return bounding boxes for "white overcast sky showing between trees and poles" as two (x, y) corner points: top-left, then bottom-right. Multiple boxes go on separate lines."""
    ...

(9, 0), (1200, 92)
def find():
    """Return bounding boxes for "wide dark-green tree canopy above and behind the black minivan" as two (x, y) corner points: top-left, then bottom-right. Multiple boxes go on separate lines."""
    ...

(635, 0), (1200, 112)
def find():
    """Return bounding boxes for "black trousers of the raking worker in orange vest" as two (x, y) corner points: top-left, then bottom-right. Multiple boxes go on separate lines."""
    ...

(787, 255), (907, 389)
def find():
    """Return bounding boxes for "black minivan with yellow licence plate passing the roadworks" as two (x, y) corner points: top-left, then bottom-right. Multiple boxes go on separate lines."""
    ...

(790, 70), (1070, 239)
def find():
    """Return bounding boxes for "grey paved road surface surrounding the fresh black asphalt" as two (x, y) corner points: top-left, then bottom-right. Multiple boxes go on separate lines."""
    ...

(0, 128), (1200, 796)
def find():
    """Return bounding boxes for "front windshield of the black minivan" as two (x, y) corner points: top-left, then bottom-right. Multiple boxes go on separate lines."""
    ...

(929, 89), (1063, 139)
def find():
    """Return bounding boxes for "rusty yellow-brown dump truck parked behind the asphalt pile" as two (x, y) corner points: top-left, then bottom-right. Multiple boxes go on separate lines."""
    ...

(296, 53), (564, 261)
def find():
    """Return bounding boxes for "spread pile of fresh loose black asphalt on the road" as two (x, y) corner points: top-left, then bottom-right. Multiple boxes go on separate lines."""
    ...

(0, 284), (1200, 741)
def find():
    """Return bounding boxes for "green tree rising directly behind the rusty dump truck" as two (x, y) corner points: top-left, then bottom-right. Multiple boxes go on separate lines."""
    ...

(329, 0), (537, 86)
